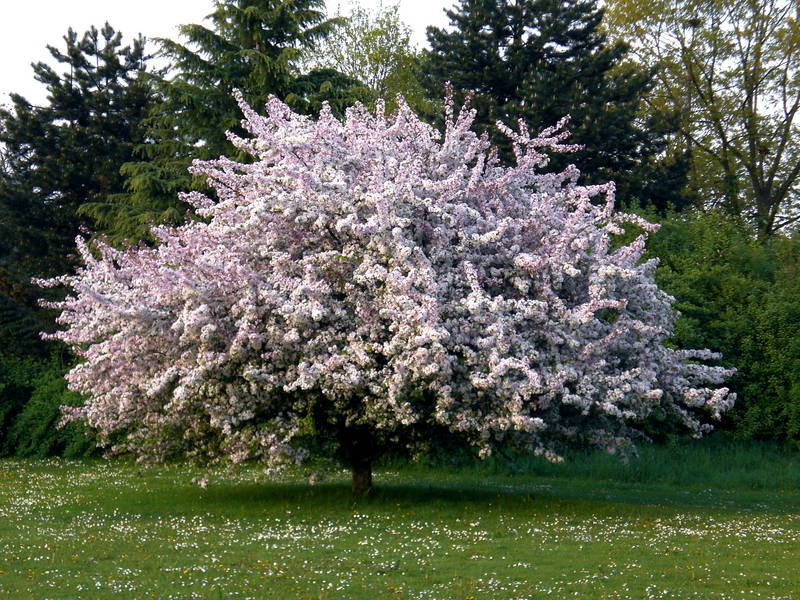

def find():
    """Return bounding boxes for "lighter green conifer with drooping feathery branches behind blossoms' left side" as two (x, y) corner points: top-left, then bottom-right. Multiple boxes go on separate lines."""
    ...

(97, 0), (360, 241)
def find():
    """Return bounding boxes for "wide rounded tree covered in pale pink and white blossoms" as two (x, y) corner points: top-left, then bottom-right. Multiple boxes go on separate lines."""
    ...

(42, 90), (733, 493)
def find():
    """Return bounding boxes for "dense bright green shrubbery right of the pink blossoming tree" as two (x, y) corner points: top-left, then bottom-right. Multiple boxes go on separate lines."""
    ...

(649, 213), (800, 444)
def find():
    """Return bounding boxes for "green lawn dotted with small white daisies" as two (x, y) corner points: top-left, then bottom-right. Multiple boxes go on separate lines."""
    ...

(0, 444), (800, 600)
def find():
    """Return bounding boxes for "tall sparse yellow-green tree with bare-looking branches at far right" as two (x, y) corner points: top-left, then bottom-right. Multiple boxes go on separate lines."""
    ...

(608, 0), (800, 237)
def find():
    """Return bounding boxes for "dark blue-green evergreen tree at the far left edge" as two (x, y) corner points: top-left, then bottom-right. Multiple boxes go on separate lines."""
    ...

(0, 23), (151, 352)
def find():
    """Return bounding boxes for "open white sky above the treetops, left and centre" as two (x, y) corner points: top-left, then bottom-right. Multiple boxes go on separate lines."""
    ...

(0, 0), (455, 103)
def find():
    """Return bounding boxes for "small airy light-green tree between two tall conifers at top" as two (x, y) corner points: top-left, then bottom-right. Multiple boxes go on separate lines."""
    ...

(306, 4), (431, 113)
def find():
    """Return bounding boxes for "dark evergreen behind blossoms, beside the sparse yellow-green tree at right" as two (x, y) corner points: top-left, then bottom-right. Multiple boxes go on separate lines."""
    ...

(425, 0), (685, 209)
